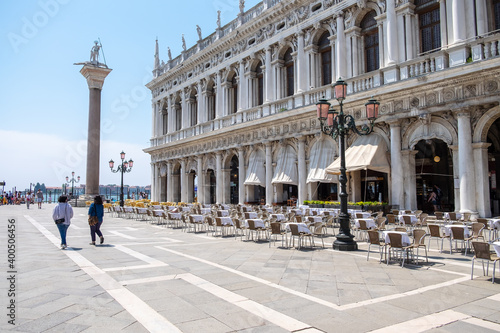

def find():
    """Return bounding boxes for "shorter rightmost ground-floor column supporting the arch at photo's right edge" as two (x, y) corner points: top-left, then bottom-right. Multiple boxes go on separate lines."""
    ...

(472, 142), (491, 217)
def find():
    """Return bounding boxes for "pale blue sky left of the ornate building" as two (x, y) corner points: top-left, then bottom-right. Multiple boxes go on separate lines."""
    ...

(0, 0), (260, 190)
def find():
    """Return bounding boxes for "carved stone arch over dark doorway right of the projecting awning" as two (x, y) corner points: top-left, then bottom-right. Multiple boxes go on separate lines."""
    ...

(401, 117), (458, 149)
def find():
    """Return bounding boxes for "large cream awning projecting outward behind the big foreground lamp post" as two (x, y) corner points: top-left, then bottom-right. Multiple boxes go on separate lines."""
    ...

(326, 134), (391, 175)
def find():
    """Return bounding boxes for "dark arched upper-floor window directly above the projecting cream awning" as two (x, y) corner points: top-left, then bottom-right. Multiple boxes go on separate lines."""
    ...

(361, 10), (380, 73)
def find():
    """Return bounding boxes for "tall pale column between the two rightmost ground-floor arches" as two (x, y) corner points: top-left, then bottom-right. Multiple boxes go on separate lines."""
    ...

(457, 109), (476, 213)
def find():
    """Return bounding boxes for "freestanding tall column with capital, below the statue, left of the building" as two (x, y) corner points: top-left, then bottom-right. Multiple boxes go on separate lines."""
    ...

(80, 63), (111, 197)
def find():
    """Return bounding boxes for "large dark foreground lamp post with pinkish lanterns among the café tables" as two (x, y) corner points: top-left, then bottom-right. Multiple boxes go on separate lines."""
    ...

(316, 78), (380, 251)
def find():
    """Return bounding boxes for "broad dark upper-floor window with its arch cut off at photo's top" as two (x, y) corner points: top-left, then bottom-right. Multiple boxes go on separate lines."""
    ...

(415, 0), (441, 53)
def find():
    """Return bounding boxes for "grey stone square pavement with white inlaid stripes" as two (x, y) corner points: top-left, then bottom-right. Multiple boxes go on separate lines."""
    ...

(0, 204), (500, 333)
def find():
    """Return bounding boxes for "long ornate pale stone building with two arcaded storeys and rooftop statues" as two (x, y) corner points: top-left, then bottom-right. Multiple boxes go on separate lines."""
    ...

(145, 0), (500, 216)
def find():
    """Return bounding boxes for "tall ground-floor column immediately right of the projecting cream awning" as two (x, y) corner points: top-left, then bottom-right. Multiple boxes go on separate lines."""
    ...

(389, 120), (404, 209)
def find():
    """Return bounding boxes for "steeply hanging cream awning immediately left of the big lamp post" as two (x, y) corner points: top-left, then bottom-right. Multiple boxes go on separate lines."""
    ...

(307, 139), (338, 183)
